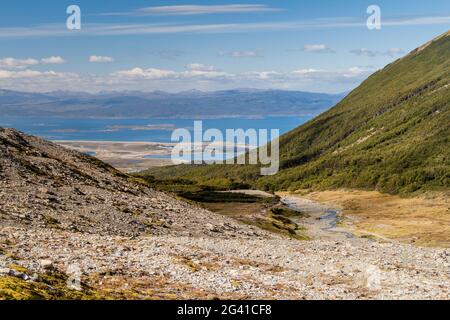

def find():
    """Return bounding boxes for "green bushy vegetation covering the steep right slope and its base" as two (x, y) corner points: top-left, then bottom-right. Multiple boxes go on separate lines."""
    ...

(142, 32), (450, 194)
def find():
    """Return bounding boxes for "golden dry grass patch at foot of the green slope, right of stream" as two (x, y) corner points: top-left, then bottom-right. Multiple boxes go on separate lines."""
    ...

(296, 190), (450, 248)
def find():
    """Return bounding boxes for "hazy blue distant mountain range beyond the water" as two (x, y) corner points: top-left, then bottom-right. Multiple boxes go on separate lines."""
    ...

(0, 89), (344, 119)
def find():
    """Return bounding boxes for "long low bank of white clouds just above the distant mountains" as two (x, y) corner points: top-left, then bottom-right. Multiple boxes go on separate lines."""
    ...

(0, 63), (374, 92)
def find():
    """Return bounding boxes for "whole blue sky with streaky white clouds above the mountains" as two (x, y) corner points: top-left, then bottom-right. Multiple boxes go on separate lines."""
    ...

(0, 0), (450, 92)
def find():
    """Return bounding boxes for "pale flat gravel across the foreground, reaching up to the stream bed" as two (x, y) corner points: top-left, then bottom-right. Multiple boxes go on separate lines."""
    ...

(0, 193), (450, 299)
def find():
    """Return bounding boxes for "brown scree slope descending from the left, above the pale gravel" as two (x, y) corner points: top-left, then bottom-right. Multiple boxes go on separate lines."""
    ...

(0, 128), (256, 236)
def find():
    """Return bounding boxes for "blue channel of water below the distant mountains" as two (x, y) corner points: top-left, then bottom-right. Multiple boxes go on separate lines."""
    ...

(0, 116), (312, 143)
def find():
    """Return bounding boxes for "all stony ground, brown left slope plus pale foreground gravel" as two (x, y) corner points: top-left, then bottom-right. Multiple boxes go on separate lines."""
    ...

(0, 129), (450, 299)
